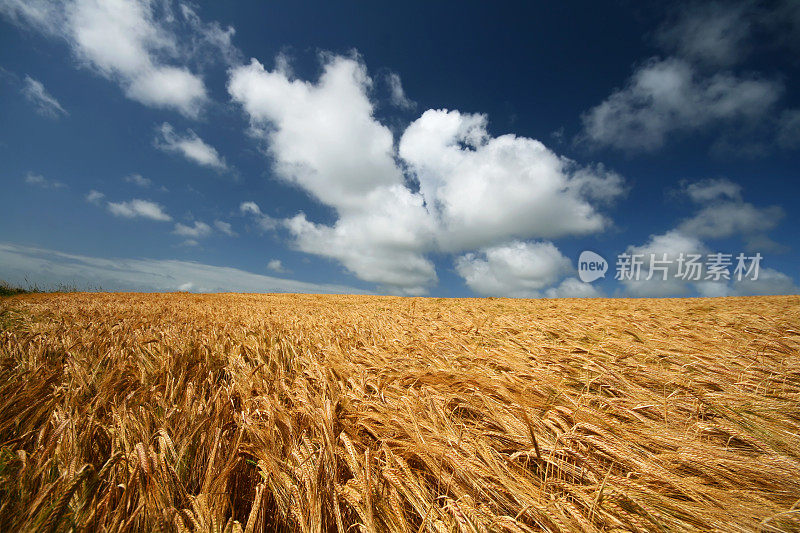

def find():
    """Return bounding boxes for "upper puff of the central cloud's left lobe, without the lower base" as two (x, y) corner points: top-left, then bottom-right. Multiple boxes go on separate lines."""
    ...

(228, 57), (403, 210)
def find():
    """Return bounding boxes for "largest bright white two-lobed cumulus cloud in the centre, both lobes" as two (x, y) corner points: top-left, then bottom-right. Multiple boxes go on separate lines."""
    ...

(228, 55), (622, 294)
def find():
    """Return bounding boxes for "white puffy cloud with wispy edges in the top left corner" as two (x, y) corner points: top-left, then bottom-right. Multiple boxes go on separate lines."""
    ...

(0, 0), (223, 118)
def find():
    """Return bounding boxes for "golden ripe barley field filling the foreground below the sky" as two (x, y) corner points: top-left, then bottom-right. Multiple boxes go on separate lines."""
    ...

(0, 294), (800, 533)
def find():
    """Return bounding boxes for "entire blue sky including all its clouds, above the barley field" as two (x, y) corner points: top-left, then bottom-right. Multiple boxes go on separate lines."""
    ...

(0, 0), (800, 297)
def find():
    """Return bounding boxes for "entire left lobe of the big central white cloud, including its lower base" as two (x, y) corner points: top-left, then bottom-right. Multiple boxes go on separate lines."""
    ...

(228, 56), (436, 294)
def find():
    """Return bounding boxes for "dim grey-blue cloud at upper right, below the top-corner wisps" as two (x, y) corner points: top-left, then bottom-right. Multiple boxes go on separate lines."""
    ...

(583, 58), (783, 151)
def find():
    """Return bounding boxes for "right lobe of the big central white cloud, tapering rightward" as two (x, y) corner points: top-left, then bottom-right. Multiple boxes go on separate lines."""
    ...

(399, 110), (623, 251)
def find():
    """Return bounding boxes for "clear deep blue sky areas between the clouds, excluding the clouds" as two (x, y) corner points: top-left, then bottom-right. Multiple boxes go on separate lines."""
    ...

(0, 1), (800, 296)
